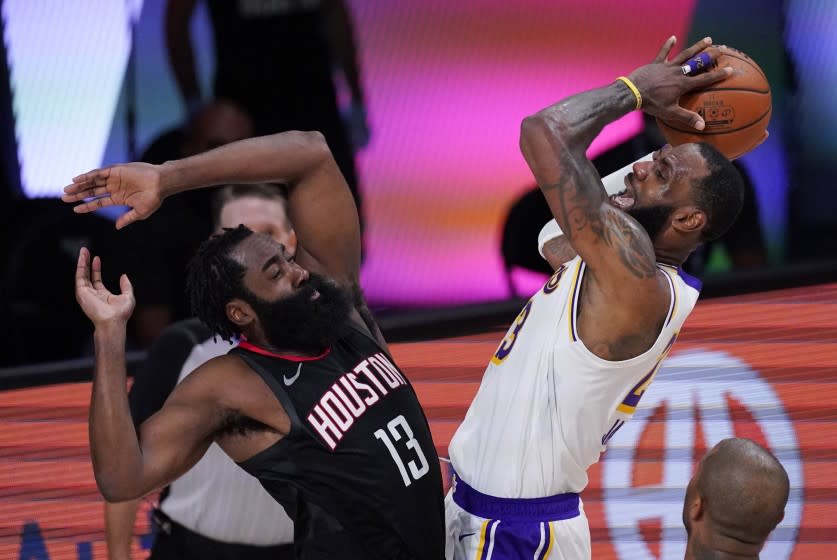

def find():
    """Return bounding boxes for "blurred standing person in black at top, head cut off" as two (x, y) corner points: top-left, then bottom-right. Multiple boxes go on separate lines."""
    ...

(166, 0), (369, 229)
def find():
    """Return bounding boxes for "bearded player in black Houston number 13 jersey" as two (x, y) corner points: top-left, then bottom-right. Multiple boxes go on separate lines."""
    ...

(63, 132), (444, 560)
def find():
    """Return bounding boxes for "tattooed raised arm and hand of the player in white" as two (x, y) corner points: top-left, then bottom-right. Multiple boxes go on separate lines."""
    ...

(520, 37), (727, 290)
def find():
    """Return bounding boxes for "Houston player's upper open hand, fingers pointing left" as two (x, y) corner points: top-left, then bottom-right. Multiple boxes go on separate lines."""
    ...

(61, 163), (163, 229)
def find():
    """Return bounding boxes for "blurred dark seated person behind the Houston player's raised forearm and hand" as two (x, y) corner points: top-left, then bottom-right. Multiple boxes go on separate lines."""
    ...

(115, 101), (253, 348)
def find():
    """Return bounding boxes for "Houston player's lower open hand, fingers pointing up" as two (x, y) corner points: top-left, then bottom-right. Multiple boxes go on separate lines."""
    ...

(76, 247), (135, 326)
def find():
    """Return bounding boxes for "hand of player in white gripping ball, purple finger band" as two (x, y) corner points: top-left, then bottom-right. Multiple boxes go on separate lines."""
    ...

(629, 36), (732, 130)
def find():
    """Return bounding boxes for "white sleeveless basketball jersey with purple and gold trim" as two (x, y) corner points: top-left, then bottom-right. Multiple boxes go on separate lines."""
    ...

(449, 257), (700, 498)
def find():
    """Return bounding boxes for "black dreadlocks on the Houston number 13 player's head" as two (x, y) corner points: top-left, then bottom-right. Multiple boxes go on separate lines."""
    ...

(186, 225), (253, 341)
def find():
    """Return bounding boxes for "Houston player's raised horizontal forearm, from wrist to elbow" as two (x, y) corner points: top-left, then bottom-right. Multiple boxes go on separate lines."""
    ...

(160, 131), (332, 196)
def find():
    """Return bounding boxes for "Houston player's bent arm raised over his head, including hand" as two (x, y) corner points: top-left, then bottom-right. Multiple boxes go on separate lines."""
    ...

(62, 131), (360, 285)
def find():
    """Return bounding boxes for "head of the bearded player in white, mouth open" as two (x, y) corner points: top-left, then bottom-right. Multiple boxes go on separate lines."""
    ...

(610, 143), (744, 258)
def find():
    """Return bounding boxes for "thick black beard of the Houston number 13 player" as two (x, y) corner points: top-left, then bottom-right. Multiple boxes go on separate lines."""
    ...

(245, 272), (352, 354)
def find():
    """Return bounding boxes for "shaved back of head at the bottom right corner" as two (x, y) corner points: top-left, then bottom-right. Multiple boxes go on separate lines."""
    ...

(683, 438), (790, 560)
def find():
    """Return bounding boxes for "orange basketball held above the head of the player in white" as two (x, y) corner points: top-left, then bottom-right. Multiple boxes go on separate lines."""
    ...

(657, 45), (771, 159)
